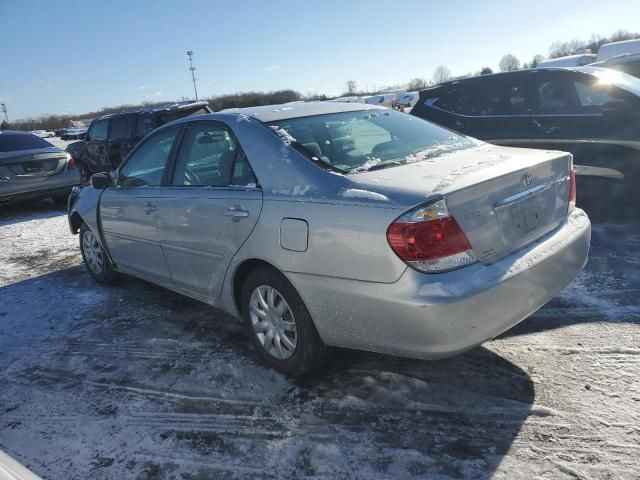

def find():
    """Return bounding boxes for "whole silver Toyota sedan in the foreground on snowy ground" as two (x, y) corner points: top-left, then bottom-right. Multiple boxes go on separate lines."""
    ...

(69, 102), (591, 375)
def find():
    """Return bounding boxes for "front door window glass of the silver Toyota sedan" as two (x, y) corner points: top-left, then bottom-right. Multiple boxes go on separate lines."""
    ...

(117, 127), (180, 187)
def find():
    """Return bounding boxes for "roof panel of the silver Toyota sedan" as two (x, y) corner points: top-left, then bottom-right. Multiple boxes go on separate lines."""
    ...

(219, 102), (384, 123)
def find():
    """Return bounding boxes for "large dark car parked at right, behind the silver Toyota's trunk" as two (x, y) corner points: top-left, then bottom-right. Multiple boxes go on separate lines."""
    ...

(411, 66), (640, 216)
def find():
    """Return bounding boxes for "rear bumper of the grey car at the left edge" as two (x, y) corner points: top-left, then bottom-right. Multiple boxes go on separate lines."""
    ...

(0, 168), (80, 203)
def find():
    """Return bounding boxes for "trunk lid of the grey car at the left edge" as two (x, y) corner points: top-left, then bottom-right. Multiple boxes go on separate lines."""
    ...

(0, 147), (67, 180)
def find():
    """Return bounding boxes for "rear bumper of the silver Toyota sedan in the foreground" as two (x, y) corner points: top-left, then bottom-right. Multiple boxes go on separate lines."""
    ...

(286, 209), (591, 358)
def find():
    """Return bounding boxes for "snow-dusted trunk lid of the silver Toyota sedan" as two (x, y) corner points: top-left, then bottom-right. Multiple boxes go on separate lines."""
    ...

(350, 146), (571, 263)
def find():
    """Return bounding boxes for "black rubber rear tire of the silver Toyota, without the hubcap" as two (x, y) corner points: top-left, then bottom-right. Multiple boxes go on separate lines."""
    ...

(241, 267), (328, 377)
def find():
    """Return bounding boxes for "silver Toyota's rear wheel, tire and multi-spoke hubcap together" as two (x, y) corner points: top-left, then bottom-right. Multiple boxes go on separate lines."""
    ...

(241, 268), (327, 377)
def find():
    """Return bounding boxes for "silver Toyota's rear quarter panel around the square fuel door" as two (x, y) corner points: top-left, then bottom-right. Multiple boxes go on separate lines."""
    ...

(221, 200), (407, 313)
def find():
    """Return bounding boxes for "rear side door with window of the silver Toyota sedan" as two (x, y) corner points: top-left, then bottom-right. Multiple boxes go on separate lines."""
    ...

(158, 121), (262, 301)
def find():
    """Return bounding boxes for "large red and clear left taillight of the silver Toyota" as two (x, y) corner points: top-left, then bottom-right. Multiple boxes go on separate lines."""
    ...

(387, 199), (477, 273)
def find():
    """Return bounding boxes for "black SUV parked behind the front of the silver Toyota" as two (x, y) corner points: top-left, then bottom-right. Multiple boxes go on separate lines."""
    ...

(67, 102), (211, 184)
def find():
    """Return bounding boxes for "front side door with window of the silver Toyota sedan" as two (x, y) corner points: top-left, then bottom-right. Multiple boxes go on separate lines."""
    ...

(99, 126), (180, 284)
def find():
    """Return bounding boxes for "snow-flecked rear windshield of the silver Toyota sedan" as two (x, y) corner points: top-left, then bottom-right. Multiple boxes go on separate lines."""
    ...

(268, 110), (478, 173)
